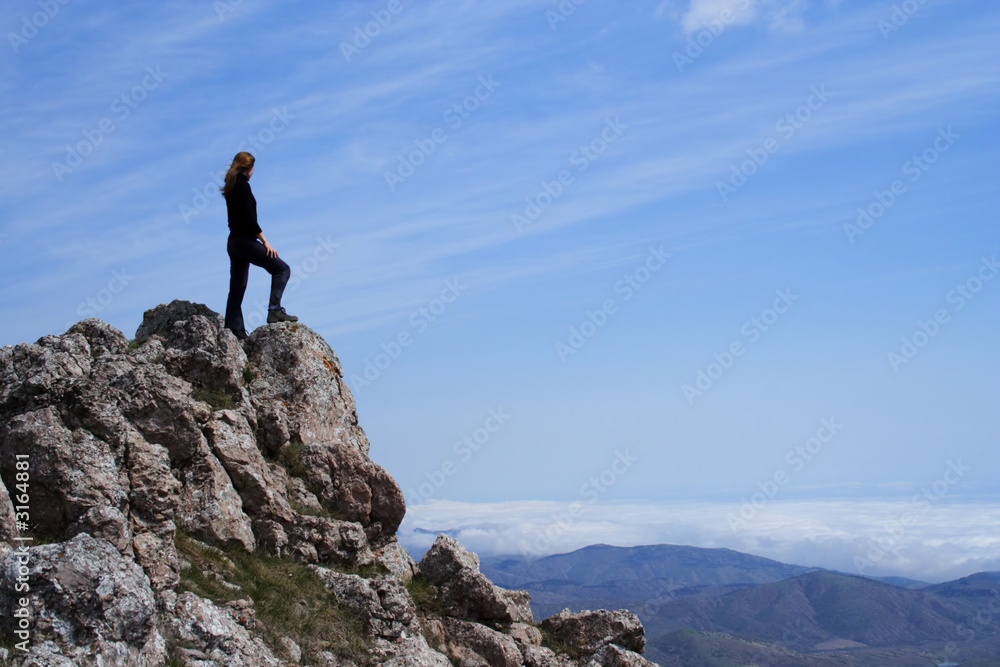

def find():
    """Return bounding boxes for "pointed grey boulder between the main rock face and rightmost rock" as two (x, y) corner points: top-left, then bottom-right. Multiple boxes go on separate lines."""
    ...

(419, 535), (534, 623)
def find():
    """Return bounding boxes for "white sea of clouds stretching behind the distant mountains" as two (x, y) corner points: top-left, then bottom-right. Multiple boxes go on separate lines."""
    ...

(399, 500), (1000, 583)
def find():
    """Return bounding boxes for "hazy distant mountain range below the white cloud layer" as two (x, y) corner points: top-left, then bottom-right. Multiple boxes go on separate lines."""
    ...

(482, 545), (1000, 667)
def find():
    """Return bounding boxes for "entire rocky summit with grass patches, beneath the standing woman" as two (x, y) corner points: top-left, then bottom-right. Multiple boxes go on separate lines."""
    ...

(0, 301), (652, 667)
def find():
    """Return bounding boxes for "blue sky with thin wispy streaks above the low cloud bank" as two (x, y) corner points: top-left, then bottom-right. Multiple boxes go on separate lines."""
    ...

(0, 0), (1000, 572)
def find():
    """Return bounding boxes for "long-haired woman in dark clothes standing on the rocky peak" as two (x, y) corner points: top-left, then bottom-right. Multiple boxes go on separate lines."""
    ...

(222, 151), (299, 340)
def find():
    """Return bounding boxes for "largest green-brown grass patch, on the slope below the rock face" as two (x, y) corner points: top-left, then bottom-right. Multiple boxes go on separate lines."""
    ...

(177, 531), (372, 665)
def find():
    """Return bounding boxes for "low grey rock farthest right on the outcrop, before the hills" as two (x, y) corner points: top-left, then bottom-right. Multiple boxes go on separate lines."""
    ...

(541, 609), (646, 655)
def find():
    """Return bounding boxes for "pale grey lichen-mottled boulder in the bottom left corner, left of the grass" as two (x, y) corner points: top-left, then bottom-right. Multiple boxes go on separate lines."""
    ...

(0, 533), (166, 665)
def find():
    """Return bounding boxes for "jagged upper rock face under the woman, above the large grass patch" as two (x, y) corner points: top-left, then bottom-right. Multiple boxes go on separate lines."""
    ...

(0, 301), (405, 589)
